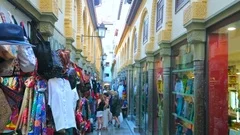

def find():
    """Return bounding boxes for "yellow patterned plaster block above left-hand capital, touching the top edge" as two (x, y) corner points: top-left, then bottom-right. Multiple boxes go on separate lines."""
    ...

(39, 0), (58, 16)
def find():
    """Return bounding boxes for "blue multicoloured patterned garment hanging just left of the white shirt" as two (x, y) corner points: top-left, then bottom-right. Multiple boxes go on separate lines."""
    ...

(28, 80), (47, 135)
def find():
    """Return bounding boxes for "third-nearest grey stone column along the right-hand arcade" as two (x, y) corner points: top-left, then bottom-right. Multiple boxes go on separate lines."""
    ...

(147, 53), (157, 135)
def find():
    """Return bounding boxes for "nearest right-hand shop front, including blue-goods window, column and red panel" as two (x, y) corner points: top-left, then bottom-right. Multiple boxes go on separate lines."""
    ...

(168, 5), (240, 135)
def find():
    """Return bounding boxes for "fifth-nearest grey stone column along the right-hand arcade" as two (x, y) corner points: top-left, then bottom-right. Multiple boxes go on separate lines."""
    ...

(127, 65), (134, 116)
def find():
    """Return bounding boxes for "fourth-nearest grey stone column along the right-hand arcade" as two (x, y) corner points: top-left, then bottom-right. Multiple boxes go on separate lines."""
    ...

(134, 61), (141, 132)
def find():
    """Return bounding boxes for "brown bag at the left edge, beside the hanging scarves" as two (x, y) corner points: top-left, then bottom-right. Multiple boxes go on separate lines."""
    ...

(0, 89), (12, 133)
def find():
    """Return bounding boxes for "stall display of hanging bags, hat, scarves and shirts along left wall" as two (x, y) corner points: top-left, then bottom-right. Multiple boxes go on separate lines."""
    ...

(0, 13), (99, 135)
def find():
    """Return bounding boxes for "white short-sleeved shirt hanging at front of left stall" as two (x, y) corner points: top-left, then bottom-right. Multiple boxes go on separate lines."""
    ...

(48, 78), (78, 131)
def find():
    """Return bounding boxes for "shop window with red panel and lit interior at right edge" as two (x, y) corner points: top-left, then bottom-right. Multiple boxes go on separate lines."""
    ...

(208, 21), (240, 135)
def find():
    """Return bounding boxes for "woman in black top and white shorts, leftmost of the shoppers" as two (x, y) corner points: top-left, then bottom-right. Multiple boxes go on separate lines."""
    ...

(97, 94), (105, 130)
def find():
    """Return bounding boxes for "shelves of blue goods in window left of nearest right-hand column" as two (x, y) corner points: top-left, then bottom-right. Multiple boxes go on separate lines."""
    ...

(172, 68), (194, 134)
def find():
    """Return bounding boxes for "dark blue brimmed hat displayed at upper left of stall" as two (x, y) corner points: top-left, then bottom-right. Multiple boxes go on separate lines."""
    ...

(0, 23), (32, 46)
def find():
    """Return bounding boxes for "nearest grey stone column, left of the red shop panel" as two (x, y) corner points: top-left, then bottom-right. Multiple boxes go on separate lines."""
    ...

(187, 28), (206, 135)
